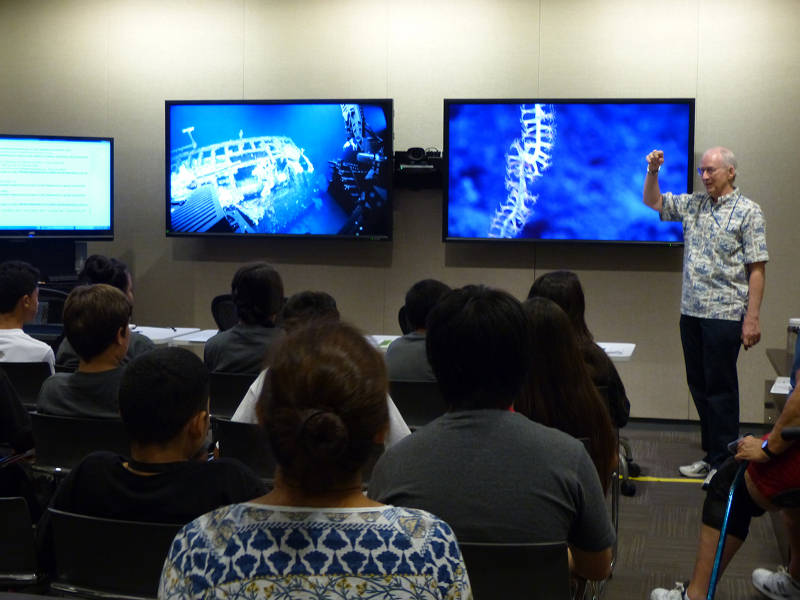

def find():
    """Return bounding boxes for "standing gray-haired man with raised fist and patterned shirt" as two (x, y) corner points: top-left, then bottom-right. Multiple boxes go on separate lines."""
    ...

(643, 147), (769, 486)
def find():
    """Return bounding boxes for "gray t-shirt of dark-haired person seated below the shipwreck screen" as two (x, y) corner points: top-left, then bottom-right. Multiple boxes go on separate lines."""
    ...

(203, 323), (285, 373)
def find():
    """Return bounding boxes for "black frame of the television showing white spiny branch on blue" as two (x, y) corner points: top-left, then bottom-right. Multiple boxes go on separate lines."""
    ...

(442, 98), (696, 246)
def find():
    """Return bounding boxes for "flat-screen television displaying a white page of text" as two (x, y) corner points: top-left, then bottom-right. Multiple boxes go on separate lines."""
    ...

(0, 134), (114, 240)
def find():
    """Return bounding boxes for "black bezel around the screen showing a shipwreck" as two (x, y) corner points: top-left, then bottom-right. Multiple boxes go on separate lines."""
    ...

(164, 98), (394, 241)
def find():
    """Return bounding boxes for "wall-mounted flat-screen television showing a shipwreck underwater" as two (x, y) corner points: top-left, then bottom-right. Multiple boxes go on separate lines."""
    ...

(165, 99), (393, 240)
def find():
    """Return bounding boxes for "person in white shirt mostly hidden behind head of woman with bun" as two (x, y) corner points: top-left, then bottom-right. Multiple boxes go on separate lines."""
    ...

(231, 291), (411, 447)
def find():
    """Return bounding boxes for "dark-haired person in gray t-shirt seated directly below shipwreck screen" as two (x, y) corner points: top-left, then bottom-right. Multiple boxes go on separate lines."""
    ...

(203, 262), (283, 373)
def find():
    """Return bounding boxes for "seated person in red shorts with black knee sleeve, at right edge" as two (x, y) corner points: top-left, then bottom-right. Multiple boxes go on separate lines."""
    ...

(650, 370), (800, 600)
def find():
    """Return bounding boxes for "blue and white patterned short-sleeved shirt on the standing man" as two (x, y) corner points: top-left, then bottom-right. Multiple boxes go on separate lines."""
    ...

(661, 188), (769, 321)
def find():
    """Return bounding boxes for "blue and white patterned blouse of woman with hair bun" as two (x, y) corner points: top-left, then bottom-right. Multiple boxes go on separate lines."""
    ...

(158, 503), (472, 600)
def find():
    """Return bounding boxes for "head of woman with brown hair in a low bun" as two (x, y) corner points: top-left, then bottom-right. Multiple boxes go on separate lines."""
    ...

(258, 321), (389, 492)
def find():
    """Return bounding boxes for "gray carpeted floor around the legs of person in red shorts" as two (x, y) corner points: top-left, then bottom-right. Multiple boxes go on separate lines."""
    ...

(603, 422), (780, 600)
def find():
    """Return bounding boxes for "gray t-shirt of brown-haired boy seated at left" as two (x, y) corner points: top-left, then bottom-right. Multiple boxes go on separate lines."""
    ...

(36, 367), (125, 419)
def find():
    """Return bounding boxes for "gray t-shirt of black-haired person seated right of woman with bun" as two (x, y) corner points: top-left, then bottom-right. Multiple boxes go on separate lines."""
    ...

(369, 409), (615, 552)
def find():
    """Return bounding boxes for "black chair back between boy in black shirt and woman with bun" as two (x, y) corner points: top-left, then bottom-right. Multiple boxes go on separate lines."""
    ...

(211, 417), (276, 480)
